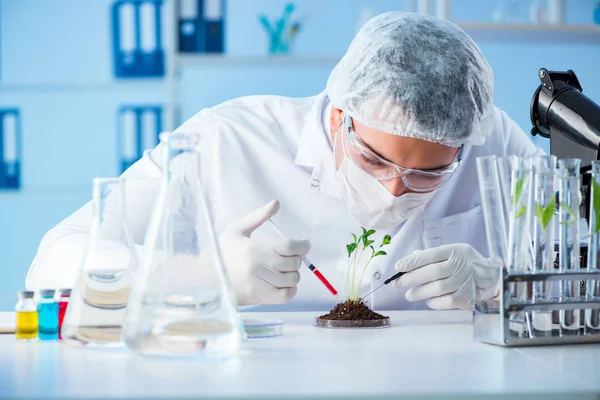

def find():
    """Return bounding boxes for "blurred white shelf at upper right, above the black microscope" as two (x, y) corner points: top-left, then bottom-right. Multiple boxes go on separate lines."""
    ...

(457, 22), (600, 44)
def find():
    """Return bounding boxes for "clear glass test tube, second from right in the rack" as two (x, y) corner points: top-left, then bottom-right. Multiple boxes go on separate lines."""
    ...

(558, 158), (581, 336)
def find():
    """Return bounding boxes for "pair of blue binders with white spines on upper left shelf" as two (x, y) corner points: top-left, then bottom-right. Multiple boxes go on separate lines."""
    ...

(111, 0), (165, 78)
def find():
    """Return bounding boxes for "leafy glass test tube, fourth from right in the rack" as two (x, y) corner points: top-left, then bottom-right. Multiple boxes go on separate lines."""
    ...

(508, 157), (533, 336)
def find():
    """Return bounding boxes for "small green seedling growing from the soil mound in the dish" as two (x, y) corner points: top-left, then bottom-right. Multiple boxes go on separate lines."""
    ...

(346, 227), (392, 302)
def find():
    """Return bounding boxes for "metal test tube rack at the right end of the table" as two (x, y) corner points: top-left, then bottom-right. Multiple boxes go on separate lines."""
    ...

(473, 268), (600, 347)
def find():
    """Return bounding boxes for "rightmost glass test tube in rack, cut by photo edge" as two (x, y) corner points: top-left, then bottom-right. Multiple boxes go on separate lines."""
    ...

(585, 161), (600, 335)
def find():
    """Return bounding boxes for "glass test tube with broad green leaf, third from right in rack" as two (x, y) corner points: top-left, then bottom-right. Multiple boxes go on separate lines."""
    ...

(532, 156), (556, 336)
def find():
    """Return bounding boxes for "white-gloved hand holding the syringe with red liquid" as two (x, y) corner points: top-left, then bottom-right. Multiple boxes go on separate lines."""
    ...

(219, 201), (310, 306)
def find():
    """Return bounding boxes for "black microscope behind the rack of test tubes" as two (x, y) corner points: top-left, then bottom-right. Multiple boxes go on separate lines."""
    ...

(531, 68), (600, 268)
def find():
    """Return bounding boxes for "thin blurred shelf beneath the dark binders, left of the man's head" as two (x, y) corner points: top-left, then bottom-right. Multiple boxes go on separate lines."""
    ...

(177, 53), (341, 66)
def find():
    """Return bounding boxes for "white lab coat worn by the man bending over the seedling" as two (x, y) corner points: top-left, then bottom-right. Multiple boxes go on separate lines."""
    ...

(27, 94), (538, 311)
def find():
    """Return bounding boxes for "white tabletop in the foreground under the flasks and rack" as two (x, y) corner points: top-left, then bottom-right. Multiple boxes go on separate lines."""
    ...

(0, 311), (600, 400)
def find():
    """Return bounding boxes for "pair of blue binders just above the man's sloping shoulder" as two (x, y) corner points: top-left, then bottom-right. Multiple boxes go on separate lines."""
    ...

(117, 105), (162, 172)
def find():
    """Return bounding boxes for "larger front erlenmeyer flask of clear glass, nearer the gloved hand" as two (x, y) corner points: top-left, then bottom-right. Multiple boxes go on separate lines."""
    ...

(123, 133), (244, 358)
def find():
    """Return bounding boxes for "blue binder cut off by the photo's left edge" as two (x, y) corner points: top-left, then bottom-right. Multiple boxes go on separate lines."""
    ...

(0, 109), (21, 189)
